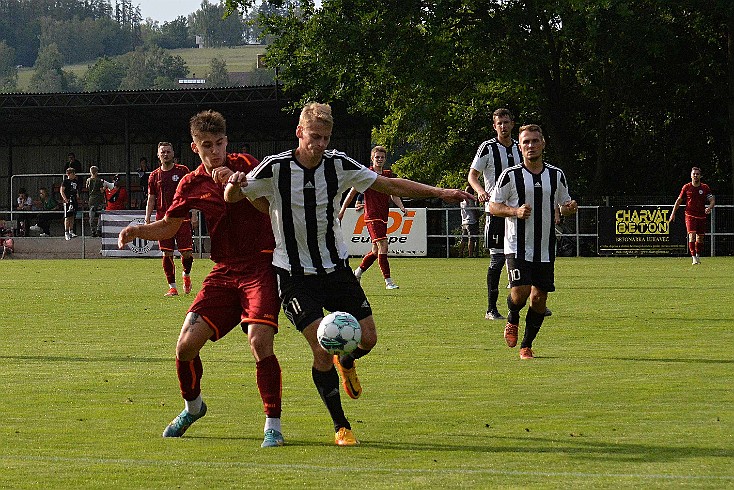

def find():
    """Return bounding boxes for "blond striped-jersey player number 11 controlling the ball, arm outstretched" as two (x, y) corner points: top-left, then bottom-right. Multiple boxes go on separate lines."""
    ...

(225, 102), (473, 446)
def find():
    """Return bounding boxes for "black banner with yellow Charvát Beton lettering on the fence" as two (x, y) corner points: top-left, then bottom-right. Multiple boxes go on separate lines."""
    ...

(597, 206), (688, 256)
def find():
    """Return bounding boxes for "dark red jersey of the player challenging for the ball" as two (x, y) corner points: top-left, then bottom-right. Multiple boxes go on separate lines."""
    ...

(165, 153), (275, 263)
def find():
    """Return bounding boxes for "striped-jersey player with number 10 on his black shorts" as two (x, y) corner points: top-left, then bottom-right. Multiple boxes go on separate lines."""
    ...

(490, 124), (577, 359)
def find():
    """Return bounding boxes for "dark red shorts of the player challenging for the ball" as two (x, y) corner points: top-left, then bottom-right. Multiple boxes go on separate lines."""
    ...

(189, 255), (280, 341)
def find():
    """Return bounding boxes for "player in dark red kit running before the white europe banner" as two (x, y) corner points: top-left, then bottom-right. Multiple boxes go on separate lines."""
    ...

(339, 146), (407, 289)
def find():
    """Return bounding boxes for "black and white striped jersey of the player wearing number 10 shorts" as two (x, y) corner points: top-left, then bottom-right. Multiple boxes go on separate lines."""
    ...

(490, 162), (571, 262)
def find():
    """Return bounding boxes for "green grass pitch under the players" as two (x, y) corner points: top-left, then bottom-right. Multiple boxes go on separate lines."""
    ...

(0, 257), (734, 489)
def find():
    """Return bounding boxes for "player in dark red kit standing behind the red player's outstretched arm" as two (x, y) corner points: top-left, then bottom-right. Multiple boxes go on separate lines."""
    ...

(145, 141), (194, 296)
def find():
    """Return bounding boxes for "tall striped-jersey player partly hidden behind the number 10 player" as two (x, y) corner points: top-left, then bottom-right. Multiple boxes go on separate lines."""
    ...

(467, 108), (521, 320)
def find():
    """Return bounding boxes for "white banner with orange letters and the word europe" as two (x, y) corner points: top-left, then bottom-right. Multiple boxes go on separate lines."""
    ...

(342, 208), (428, 257)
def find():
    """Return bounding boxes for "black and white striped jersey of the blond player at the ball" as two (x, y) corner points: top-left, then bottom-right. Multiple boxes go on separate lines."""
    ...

(243, 150), (377, 275)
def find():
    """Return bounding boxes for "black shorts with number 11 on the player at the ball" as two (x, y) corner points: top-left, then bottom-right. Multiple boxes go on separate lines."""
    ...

(275, 267), (372, 332)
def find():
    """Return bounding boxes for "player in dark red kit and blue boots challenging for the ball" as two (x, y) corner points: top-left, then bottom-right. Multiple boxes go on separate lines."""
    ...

(118, 111), (283, 447)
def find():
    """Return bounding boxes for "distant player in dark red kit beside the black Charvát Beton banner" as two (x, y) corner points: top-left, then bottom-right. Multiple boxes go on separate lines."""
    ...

(669, 167), (716, 265)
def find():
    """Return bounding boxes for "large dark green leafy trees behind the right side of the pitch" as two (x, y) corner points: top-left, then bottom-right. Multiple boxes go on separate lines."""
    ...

(226, 0), (734, 199)
